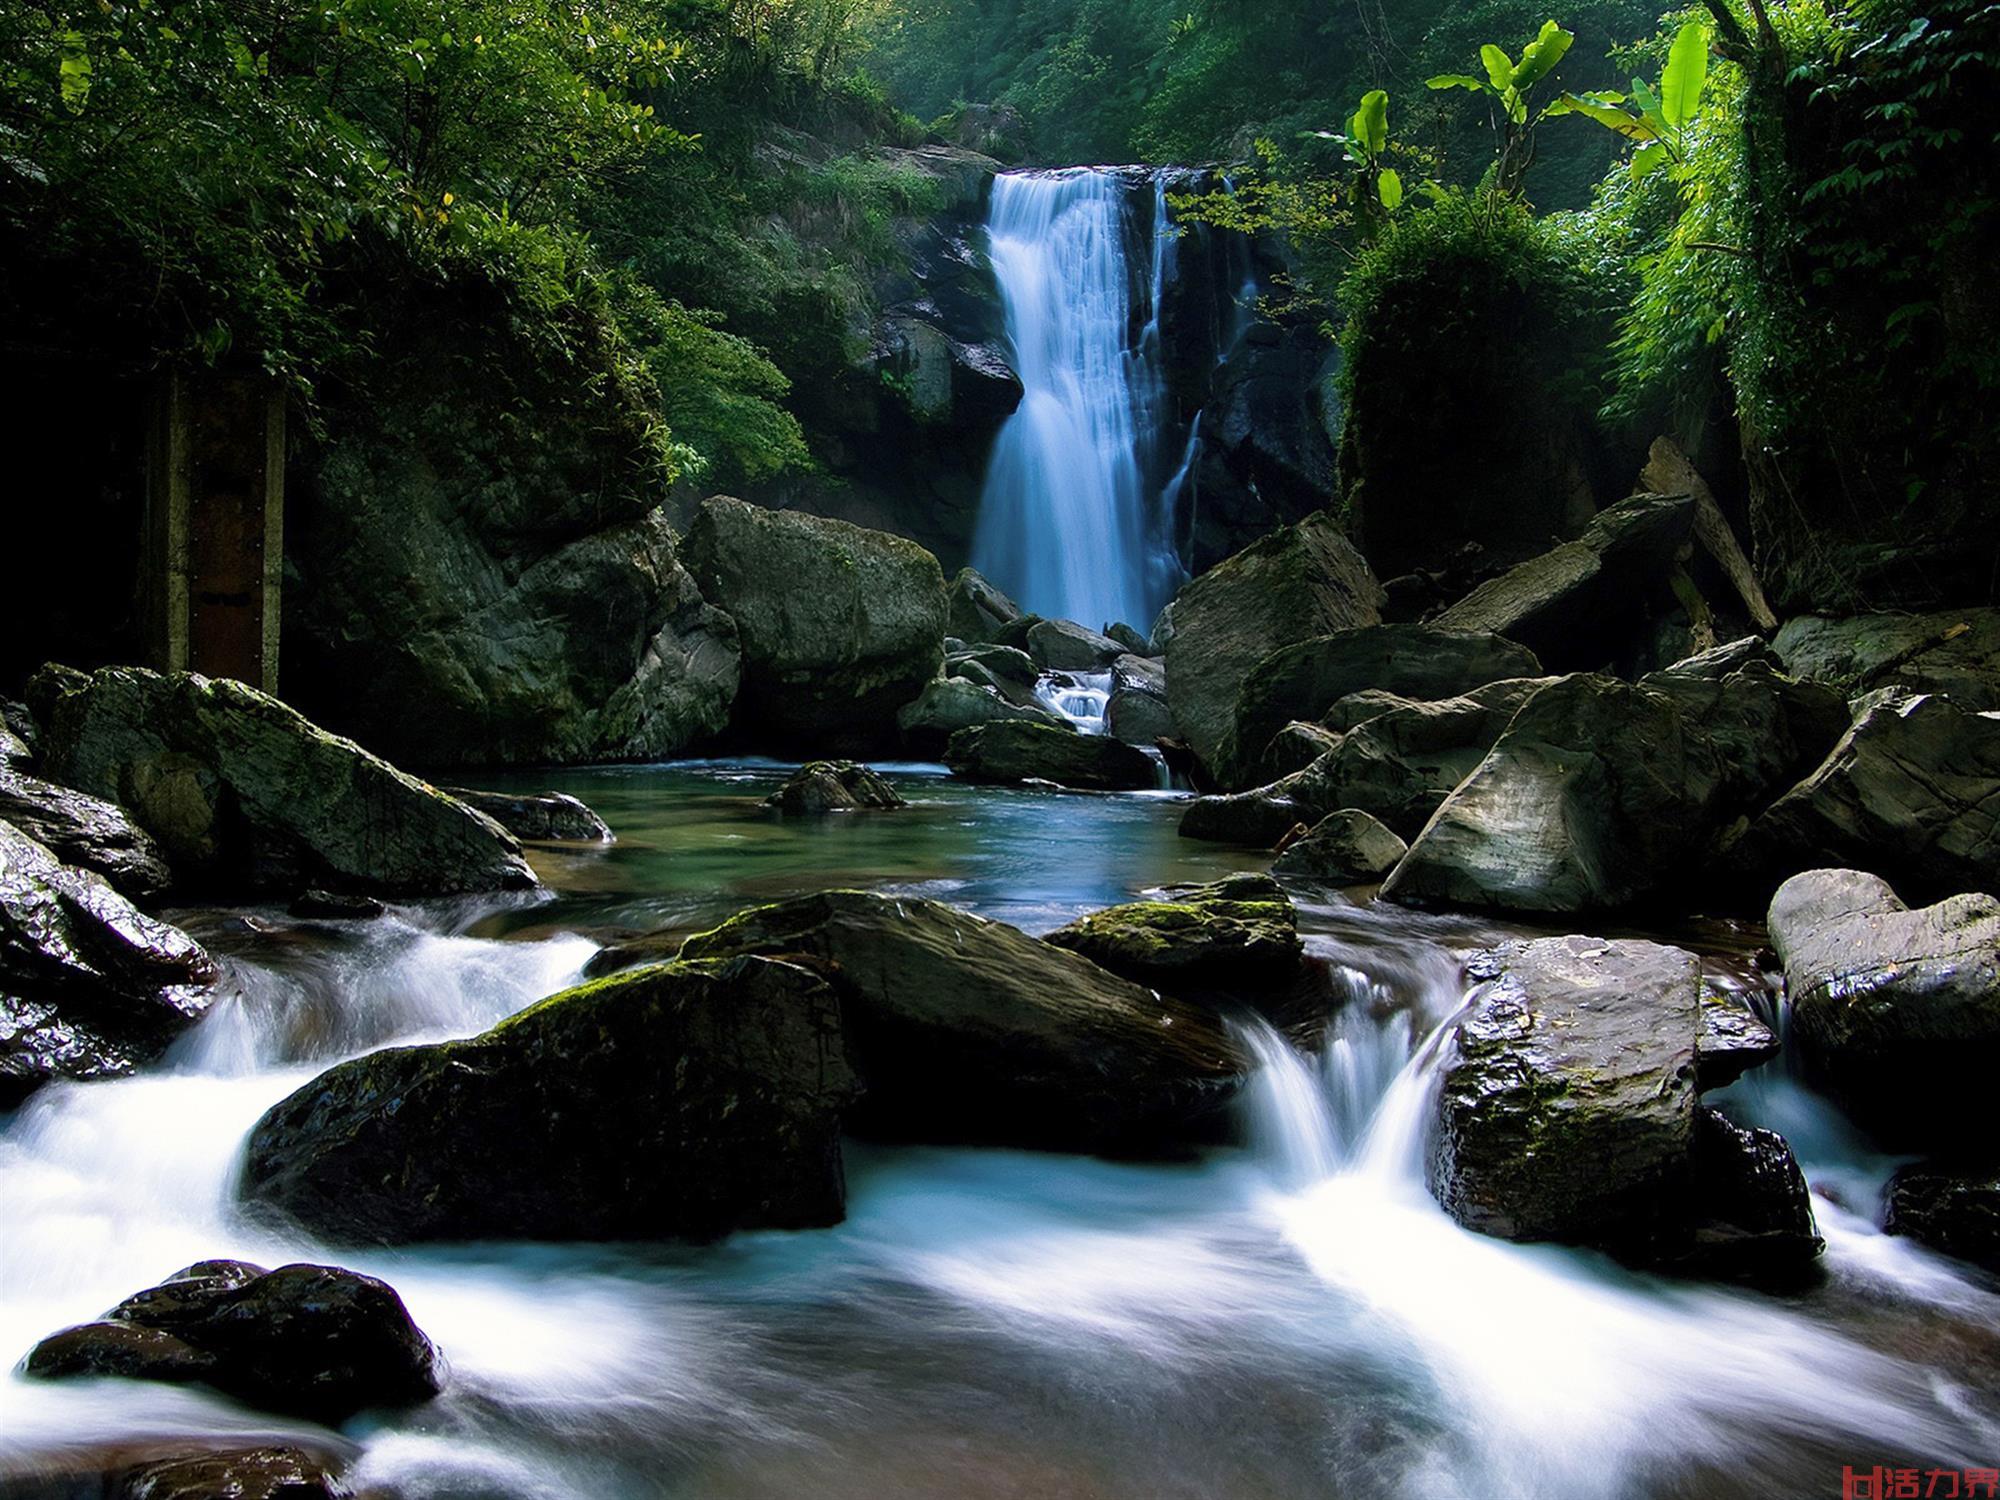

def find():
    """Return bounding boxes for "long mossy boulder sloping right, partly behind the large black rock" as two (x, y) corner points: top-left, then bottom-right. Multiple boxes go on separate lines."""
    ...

(682, 890), (1248, 1154)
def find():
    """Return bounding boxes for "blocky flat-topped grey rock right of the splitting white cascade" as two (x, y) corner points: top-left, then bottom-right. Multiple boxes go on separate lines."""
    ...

(1428, 936), (1700, 1248)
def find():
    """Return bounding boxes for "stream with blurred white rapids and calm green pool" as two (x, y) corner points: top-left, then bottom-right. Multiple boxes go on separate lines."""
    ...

(0, 762), (2000, 1500)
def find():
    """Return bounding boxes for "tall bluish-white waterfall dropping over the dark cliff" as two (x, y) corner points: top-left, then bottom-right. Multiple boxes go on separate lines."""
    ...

(972, 168), (1182, 630)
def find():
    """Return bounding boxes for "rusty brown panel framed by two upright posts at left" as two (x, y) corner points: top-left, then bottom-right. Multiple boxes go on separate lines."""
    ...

(142, 372), (286, 692)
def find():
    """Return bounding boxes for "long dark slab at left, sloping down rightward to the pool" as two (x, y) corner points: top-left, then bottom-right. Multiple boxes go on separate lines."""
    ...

(34, 666), (536, 896)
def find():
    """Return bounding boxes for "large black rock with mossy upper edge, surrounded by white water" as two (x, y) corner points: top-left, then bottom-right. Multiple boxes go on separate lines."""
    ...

(238, 958), (858, 1244)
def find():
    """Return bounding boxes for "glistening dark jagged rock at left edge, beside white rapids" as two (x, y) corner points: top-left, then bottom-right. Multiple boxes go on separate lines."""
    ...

(0, 822), (218, 1108)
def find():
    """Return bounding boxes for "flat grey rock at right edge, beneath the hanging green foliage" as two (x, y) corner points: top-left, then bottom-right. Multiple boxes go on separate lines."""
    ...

(1772, 608), (2000, 714)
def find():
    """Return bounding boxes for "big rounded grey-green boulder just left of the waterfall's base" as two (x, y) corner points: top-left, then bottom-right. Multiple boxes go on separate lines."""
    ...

(682, 496), (948, 754)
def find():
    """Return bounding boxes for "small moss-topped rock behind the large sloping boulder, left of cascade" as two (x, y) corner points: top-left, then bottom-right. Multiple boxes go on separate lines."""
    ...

(1046, 874), (1304, 1002)
